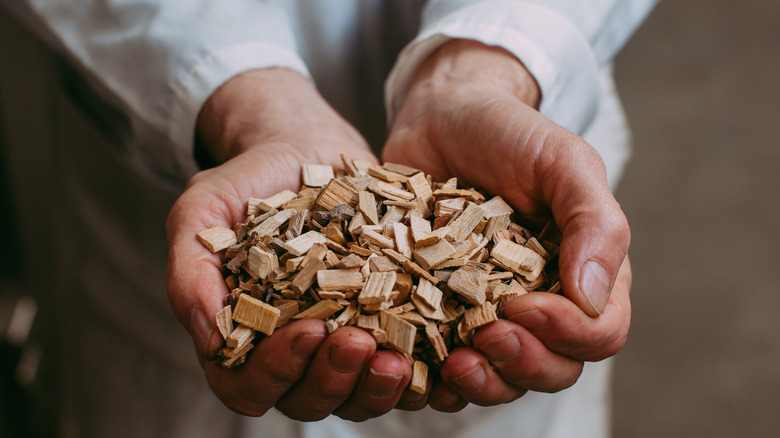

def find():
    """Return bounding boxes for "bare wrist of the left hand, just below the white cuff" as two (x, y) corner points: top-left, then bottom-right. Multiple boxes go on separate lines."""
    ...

(196, 68), (368, 164)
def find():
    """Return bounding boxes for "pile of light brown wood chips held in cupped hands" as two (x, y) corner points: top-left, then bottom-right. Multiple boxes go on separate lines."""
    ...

(197, 156), (560, 393)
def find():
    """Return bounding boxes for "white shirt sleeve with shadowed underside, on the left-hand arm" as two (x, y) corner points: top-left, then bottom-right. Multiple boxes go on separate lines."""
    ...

(0, 0), (309, 173)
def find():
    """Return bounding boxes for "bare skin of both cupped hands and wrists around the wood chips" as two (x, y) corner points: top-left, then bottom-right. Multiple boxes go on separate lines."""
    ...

(166, 40), (631, 421)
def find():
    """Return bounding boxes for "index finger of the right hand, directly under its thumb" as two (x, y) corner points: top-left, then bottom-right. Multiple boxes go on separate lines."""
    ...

(504, 259), (631, 361)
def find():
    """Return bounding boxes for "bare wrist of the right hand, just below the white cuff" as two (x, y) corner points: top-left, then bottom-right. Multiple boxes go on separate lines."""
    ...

(408, 39), (541, 109)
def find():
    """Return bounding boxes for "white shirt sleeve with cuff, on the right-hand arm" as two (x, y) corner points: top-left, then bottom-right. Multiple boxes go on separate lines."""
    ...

(385, 0), (657, 133)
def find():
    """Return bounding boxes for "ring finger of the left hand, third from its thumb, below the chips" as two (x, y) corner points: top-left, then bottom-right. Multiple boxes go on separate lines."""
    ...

(334, 350), (412, 421)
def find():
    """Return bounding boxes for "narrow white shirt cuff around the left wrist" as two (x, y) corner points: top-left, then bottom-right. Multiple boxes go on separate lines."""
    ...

(167, 41), (311, 175)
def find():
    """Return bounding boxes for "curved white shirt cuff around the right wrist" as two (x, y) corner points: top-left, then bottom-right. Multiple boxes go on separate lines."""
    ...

(385, 1), (601, 134)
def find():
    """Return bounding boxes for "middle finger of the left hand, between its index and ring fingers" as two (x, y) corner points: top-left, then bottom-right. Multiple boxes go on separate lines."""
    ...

(276, 327), (376, 421)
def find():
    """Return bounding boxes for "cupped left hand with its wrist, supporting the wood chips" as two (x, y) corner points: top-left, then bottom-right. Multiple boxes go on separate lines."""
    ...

(166, 69), (411, 420)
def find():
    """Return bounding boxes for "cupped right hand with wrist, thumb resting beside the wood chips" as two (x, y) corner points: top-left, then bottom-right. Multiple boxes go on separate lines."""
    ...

(383, 40), (631, 411)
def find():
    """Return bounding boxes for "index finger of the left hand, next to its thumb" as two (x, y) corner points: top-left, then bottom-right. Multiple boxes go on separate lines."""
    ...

(205, 320), (328, 416)
